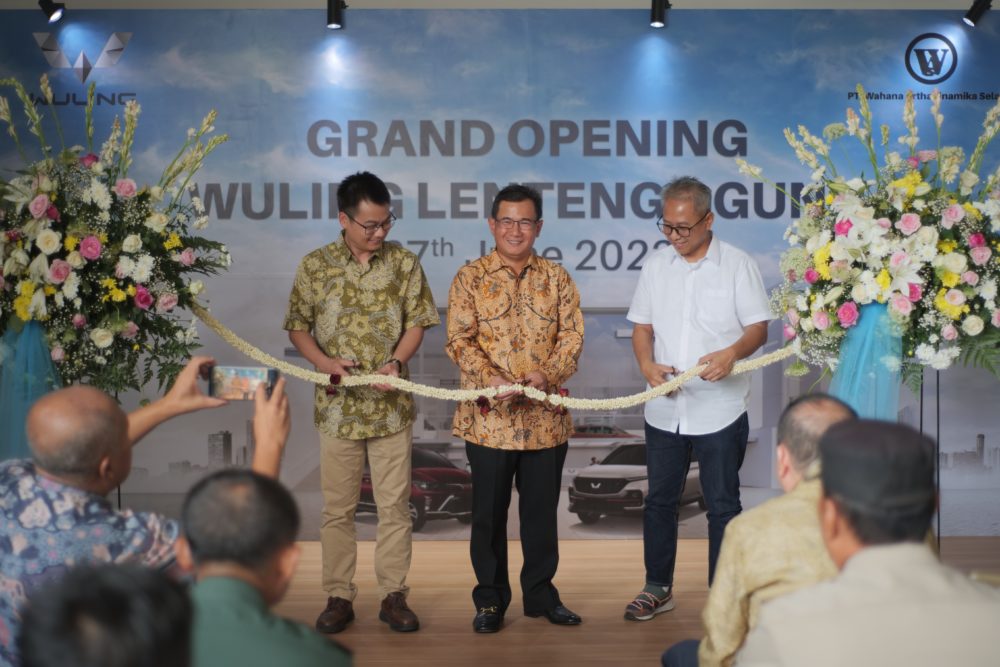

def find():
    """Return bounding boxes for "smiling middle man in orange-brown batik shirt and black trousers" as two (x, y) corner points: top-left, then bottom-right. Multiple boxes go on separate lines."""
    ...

(447, 185), (583, 632)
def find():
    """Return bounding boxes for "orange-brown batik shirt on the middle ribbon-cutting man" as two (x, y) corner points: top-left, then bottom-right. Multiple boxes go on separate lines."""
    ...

(446, 250), (583, 450)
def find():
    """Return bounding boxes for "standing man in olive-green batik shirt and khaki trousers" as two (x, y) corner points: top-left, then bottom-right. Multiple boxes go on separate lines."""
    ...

(284, 172), (440, 633)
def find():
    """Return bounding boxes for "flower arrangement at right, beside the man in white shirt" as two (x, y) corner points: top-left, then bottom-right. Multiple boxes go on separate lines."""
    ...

(737, 85), (1000, 384)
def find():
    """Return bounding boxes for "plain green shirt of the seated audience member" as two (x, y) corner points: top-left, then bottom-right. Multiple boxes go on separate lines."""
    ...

(191, 577), (351, 667)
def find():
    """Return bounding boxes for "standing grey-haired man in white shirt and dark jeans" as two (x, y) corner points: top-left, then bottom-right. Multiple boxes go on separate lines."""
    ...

(625, 177), (771, 621)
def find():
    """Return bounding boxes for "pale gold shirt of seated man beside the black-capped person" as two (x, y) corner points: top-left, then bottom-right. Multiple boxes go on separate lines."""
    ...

(698, 479), (837, 667)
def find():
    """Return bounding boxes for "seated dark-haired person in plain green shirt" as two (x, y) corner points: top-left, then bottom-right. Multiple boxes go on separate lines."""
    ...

(177, 470), (351, 667)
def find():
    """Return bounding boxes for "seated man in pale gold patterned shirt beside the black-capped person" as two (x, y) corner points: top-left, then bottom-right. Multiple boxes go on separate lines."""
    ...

(663, 394), (857, 667)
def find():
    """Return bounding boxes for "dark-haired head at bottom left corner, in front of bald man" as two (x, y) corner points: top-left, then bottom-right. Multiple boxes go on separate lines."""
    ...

(17, 564), (191, 667)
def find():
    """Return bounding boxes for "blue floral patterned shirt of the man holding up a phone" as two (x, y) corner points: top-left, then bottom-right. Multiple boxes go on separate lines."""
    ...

(0, 460), (178, 665)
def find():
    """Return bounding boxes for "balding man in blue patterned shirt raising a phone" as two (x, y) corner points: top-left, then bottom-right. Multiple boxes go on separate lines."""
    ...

(0, 357), (290, 664)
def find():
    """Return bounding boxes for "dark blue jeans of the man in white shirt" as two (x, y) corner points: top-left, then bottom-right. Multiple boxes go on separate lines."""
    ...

(642, 412), (750, 586)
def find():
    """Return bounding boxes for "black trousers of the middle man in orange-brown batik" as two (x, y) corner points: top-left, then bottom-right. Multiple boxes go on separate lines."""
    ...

(465, 442), (567, 613)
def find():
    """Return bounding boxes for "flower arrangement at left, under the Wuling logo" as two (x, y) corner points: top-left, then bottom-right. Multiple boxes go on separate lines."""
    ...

(0, 76), (230, 394)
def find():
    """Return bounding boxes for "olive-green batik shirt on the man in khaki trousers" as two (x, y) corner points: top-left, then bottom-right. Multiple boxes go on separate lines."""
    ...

(284, 232), (440, 440)
